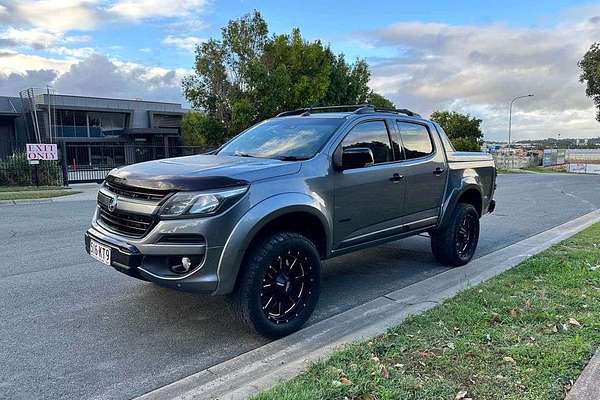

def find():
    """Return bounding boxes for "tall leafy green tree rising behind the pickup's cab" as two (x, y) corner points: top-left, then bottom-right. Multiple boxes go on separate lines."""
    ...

(182, 11), (393, 143)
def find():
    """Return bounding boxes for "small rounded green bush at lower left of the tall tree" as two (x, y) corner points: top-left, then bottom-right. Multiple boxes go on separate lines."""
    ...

(181, 111), (225, 147)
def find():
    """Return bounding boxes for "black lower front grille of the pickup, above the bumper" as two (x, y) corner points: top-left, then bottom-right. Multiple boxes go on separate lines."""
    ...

(98, 193), (155, 237)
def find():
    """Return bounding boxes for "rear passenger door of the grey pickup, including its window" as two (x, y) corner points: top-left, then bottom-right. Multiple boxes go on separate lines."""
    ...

(396, 120), (448, 222)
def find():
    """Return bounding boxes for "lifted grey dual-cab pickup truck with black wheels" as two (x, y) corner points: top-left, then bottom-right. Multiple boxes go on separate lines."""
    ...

(85, 105), (496, 338)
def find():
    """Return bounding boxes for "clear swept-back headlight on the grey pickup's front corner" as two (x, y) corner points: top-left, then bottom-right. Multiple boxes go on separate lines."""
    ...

(159, 186), (248, 217)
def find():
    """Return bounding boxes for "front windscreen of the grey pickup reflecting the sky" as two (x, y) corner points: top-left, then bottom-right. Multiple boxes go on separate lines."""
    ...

(219, 117), (343, 161)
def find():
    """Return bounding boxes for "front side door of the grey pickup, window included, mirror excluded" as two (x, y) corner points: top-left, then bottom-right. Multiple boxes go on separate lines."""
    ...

(333, 119), (405, 248)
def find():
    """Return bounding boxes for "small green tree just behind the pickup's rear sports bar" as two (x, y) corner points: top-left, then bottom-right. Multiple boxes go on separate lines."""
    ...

(430, 111), (483, 151)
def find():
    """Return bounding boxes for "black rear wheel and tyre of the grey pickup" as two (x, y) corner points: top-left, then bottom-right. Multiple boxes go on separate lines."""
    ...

(430, 203), (479, 267)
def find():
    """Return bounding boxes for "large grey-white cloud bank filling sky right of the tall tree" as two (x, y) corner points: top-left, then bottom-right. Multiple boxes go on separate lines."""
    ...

(357, 12), (600, 138)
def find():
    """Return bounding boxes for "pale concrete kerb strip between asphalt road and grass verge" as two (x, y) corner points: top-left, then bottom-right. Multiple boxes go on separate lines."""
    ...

(138, 210), (600, 400)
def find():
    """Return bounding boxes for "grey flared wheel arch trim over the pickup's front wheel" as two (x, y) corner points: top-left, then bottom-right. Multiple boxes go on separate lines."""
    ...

(213, 193), (332, 295)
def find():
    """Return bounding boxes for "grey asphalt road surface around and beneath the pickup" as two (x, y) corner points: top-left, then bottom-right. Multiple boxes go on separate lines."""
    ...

(0, 174), (600, 399)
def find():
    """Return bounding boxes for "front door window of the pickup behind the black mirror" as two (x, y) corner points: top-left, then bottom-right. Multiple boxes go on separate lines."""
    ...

(342, 121), (392, 164)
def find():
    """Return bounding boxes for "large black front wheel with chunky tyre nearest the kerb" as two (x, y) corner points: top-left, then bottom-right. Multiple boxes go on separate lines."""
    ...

(232, 232), (321, 338)
